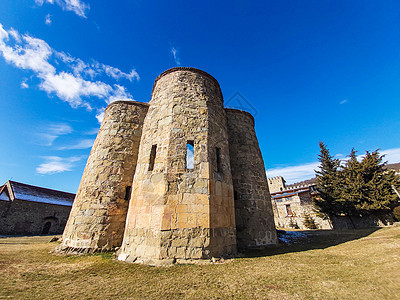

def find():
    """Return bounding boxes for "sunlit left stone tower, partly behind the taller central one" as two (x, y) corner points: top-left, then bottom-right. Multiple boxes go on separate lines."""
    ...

(60, 101), (148, 252)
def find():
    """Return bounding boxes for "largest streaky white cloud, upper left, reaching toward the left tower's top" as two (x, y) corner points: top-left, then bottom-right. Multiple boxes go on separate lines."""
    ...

(0, 24), (139, 109)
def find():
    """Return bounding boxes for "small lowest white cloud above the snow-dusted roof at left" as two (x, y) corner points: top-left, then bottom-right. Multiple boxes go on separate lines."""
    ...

(36, 156), (84, 175)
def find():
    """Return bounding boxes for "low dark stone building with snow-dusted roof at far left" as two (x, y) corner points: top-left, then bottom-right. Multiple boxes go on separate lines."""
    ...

(0, 180), (75, 235)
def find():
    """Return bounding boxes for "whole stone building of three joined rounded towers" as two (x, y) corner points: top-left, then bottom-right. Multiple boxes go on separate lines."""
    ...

(58, 67), (277, 264)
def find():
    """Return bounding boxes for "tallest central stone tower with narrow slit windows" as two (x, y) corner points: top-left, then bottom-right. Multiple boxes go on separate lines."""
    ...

(118, 68), (236, 264)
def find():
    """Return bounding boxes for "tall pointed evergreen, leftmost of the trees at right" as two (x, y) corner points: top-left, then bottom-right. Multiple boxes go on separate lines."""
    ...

(313, 142), (342, 216)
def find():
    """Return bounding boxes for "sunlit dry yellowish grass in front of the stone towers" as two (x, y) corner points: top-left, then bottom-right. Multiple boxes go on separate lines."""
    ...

(0, 227), (400, 299)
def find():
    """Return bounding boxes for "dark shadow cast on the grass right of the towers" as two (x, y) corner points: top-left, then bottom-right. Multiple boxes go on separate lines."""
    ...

(241, 227), (380, 258)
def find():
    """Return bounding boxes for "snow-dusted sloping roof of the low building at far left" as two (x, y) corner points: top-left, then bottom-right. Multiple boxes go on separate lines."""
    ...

(0, 180), (75, 206)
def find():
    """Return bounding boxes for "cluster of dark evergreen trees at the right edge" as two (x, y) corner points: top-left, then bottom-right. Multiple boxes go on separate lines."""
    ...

(314, 142), (400, 220)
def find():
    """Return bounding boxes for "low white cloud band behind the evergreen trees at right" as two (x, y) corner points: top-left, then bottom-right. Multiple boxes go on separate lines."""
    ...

(267, 148), (400, 184)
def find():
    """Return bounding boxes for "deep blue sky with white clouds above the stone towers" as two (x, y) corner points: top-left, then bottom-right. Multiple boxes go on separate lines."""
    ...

(0, 0), (400, 192)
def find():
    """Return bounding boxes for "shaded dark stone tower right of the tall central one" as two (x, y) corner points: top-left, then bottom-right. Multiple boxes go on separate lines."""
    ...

(225, 108), (277, 249)
